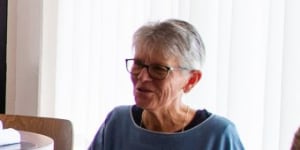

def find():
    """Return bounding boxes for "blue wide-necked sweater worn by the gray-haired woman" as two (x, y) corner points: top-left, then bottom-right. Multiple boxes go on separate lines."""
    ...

(89, 106), (244, 150)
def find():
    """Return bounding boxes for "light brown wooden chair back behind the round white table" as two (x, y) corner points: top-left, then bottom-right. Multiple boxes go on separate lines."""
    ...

(0, 114), (73, 150)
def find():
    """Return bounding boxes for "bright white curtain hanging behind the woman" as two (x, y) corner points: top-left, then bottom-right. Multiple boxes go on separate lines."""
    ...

(41, 0), (300, 150)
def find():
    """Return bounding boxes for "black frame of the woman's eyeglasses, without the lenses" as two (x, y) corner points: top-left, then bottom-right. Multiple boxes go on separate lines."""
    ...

(125, 58), (190, 80)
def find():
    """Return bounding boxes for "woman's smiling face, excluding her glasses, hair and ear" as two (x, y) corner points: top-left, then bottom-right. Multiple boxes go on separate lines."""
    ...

(131, 51), (188, 110)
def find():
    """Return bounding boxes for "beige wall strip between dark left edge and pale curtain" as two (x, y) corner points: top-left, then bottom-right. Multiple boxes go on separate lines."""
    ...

(6, 0), (43, 115)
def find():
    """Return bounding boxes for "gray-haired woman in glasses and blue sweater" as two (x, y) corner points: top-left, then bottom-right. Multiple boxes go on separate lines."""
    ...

(89, 19), (244, 150)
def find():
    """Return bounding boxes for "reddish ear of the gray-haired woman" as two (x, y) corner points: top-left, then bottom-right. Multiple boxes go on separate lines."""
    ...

(183, 70), (202, 93)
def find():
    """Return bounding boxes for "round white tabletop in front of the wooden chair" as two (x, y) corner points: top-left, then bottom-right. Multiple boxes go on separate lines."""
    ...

(0, 131), (54, 150)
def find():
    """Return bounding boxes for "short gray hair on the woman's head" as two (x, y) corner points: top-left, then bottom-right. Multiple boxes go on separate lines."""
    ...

(133, 19), (205, 70)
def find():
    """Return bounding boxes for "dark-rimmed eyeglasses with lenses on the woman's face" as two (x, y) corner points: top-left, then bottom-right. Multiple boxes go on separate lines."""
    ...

(125, 59), (187, 80)
